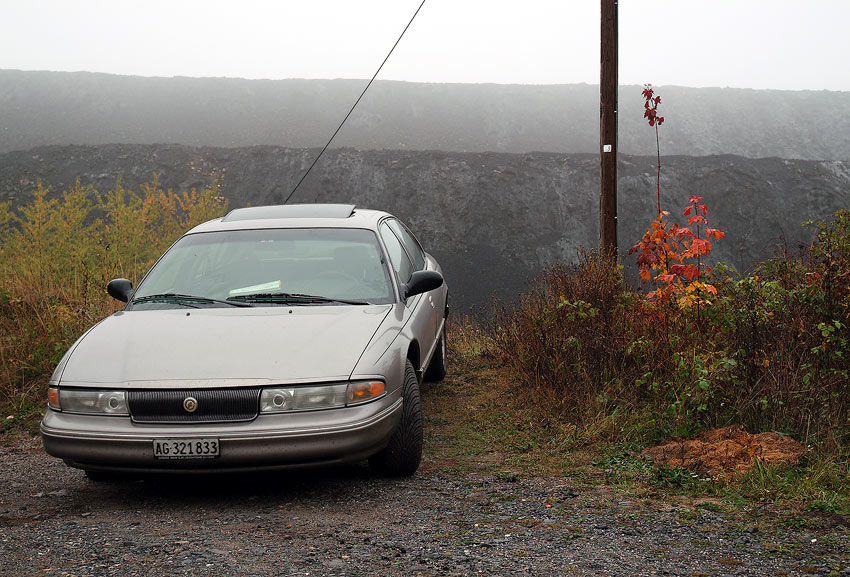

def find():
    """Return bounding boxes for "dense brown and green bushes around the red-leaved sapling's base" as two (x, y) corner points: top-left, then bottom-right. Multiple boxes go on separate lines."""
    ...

(493, 210), (850, 453)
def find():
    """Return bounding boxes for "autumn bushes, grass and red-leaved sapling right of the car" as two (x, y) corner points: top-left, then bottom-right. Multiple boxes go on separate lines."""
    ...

(425, 85), (850, 512)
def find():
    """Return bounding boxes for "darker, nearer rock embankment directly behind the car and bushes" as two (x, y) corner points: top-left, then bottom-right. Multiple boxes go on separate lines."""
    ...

(0, 145), (850, 314)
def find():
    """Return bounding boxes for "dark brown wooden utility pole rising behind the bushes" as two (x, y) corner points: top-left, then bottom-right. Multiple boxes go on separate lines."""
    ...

(599, 0), (618, 252)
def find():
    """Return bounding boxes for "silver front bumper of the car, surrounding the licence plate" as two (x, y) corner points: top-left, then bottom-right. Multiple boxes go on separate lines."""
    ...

(41, 392), (402, 473)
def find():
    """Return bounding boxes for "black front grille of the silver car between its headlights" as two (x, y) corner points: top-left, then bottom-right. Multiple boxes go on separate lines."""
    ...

(127, 387), (260, 423)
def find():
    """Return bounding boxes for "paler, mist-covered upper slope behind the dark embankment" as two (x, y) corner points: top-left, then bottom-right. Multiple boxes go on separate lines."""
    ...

(0, 70), (850, 160)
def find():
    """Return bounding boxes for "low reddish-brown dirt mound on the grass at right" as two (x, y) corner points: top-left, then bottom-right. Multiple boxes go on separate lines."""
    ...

(642, 425), (806, 473)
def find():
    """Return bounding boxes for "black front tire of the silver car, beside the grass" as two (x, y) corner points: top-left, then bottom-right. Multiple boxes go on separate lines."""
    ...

(369, 359), (422, 477)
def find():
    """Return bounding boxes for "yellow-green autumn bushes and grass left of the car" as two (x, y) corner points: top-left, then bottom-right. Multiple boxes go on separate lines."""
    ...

(0, 177), (226, 430)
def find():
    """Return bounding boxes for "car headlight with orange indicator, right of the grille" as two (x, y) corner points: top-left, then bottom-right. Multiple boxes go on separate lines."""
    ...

(260, 381), (385, 413)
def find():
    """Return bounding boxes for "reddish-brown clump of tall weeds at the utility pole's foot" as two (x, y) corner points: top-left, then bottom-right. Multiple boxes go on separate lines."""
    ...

(492, 253), (630, 413)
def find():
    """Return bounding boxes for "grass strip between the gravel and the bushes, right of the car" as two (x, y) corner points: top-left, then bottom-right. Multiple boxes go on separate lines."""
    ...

(422, 329), (850, 527)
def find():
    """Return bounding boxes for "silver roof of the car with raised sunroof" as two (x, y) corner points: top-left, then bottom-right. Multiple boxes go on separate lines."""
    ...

(186, 204), (390, 234)
